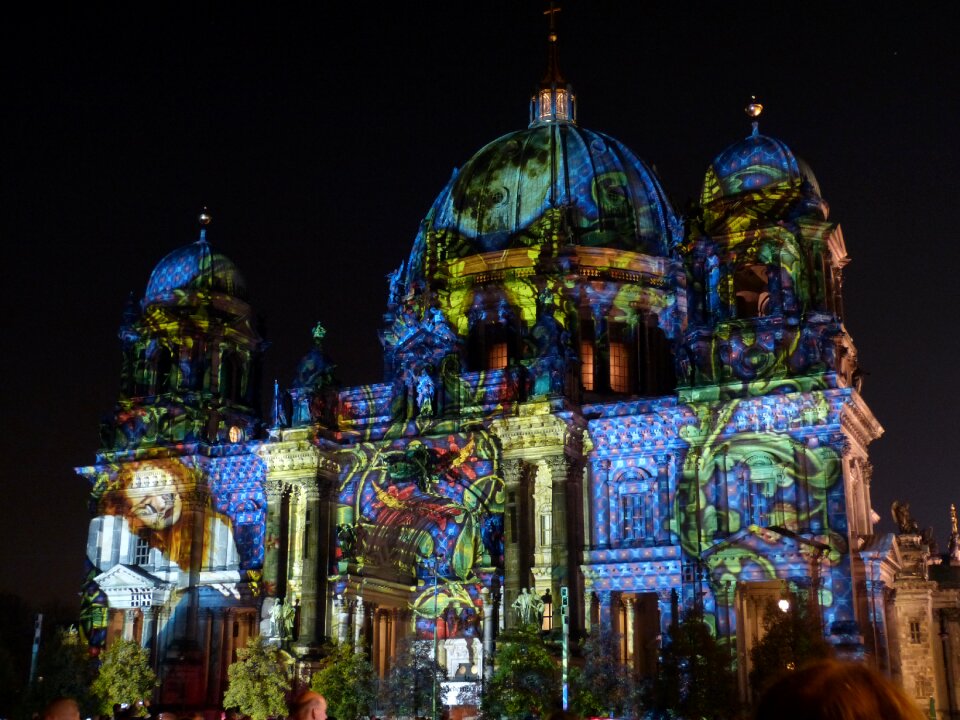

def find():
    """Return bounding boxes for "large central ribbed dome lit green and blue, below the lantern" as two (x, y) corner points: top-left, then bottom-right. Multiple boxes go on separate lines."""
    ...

(409, 123), (675, 276)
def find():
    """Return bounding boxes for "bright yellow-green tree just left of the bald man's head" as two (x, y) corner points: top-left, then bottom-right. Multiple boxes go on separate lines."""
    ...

(223, 635), (293, 720)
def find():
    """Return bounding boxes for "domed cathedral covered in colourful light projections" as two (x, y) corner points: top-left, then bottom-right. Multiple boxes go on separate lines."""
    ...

(79, 19), (960, 708)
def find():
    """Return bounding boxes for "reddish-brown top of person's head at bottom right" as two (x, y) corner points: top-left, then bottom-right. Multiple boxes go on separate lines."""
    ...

(755, 660), (923, 720)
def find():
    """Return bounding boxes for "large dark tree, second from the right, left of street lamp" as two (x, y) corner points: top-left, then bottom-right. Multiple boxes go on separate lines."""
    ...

(642, 608), (740, 720)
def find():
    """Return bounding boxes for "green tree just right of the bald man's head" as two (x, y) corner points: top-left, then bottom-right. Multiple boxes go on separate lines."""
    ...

(310, 643), (377, 720)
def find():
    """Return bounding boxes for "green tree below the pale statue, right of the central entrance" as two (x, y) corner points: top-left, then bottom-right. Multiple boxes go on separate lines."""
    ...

(481, 623), (560, 718)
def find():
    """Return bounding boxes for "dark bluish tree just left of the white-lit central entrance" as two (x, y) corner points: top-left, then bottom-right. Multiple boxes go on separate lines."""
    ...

(380, 638), (447, 715)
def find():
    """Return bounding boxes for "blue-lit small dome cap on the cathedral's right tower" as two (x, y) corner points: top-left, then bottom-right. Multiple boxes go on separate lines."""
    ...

(701, 132), (819, 205)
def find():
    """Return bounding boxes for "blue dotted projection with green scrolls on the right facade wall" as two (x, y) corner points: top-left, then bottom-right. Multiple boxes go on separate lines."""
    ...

(584, 384), (854, 638)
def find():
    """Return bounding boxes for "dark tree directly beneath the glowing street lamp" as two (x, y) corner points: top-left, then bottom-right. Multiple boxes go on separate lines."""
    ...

(750, 600), (833, 696)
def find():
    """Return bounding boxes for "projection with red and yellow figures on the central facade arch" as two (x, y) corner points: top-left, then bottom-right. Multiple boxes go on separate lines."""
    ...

(337, 431), (504, 637)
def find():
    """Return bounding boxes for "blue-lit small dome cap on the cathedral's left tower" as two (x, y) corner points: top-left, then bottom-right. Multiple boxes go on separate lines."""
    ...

(143, 239), (247, 305)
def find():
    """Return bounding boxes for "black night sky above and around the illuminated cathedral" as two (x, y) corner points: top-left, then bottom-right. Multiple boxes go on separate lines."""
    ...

(0, 0), (960, 603)
